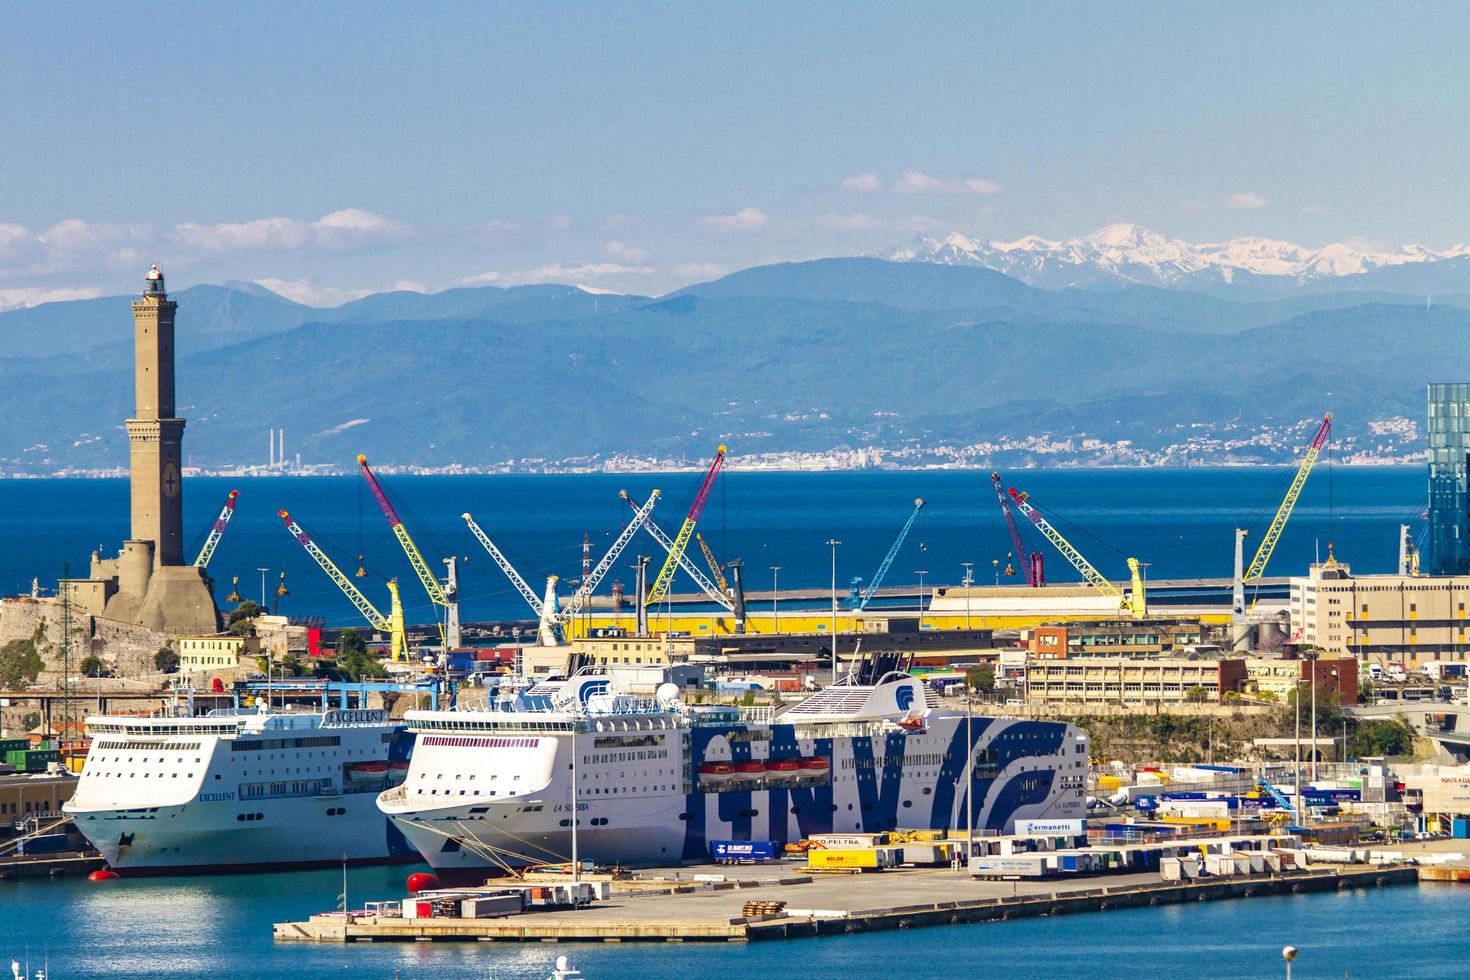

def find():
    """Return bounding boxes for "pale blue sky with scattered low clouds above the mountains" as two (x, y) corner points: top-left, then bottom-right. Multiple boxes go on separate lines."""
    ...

(0, 1), (1470, 307)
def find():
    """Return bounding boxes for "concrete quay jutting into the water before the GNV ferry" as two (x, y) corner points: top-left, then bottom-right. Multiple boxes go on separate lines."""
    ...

(273, 865), (1419, 943)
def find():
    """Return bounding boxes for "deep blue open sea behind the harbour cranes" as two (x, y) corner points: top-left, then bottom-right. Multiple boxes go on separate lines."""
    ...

(0, 466), (1424, 626)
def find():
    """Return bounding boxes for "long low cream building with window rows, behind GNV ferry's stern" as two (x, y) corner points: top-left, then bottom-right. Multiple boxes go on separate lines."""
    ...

(1026, 657), (1245, 707)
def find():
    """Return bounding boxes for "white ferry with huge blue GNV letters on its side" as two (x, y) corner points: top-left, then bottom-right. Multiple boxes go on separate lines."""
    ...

(378, 658), (1088, 882)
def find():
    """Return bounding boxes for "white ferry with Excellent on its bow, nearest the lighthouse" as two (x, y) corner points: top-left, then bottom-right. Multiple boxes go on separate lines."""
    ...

(63, 707), (417, 873)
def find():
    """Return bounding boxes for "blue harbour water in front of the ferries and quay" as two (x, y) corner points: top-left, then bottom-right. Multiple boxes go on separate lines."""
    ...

(0, 867), (1470, 980)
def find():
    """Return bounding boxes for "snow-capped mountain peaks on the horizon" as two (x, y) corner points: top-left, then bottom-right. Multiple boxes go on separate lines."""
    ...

(876, 225), (1470, 289)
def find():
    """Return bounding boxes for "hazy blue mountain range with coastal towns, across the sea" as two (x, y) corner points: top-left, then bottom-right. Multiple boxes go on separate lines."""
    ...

(0, 239), (1470, 473)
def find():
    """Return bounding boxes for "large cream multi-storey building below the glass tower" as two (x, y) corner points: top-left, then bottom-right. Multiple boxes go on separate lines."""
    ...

(1291, 561), (1470, 667)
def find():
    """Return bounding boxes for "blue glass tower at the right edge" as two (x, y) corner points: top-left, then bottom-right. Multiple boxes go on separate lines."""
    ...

(1427, 383), (1470, 574)
